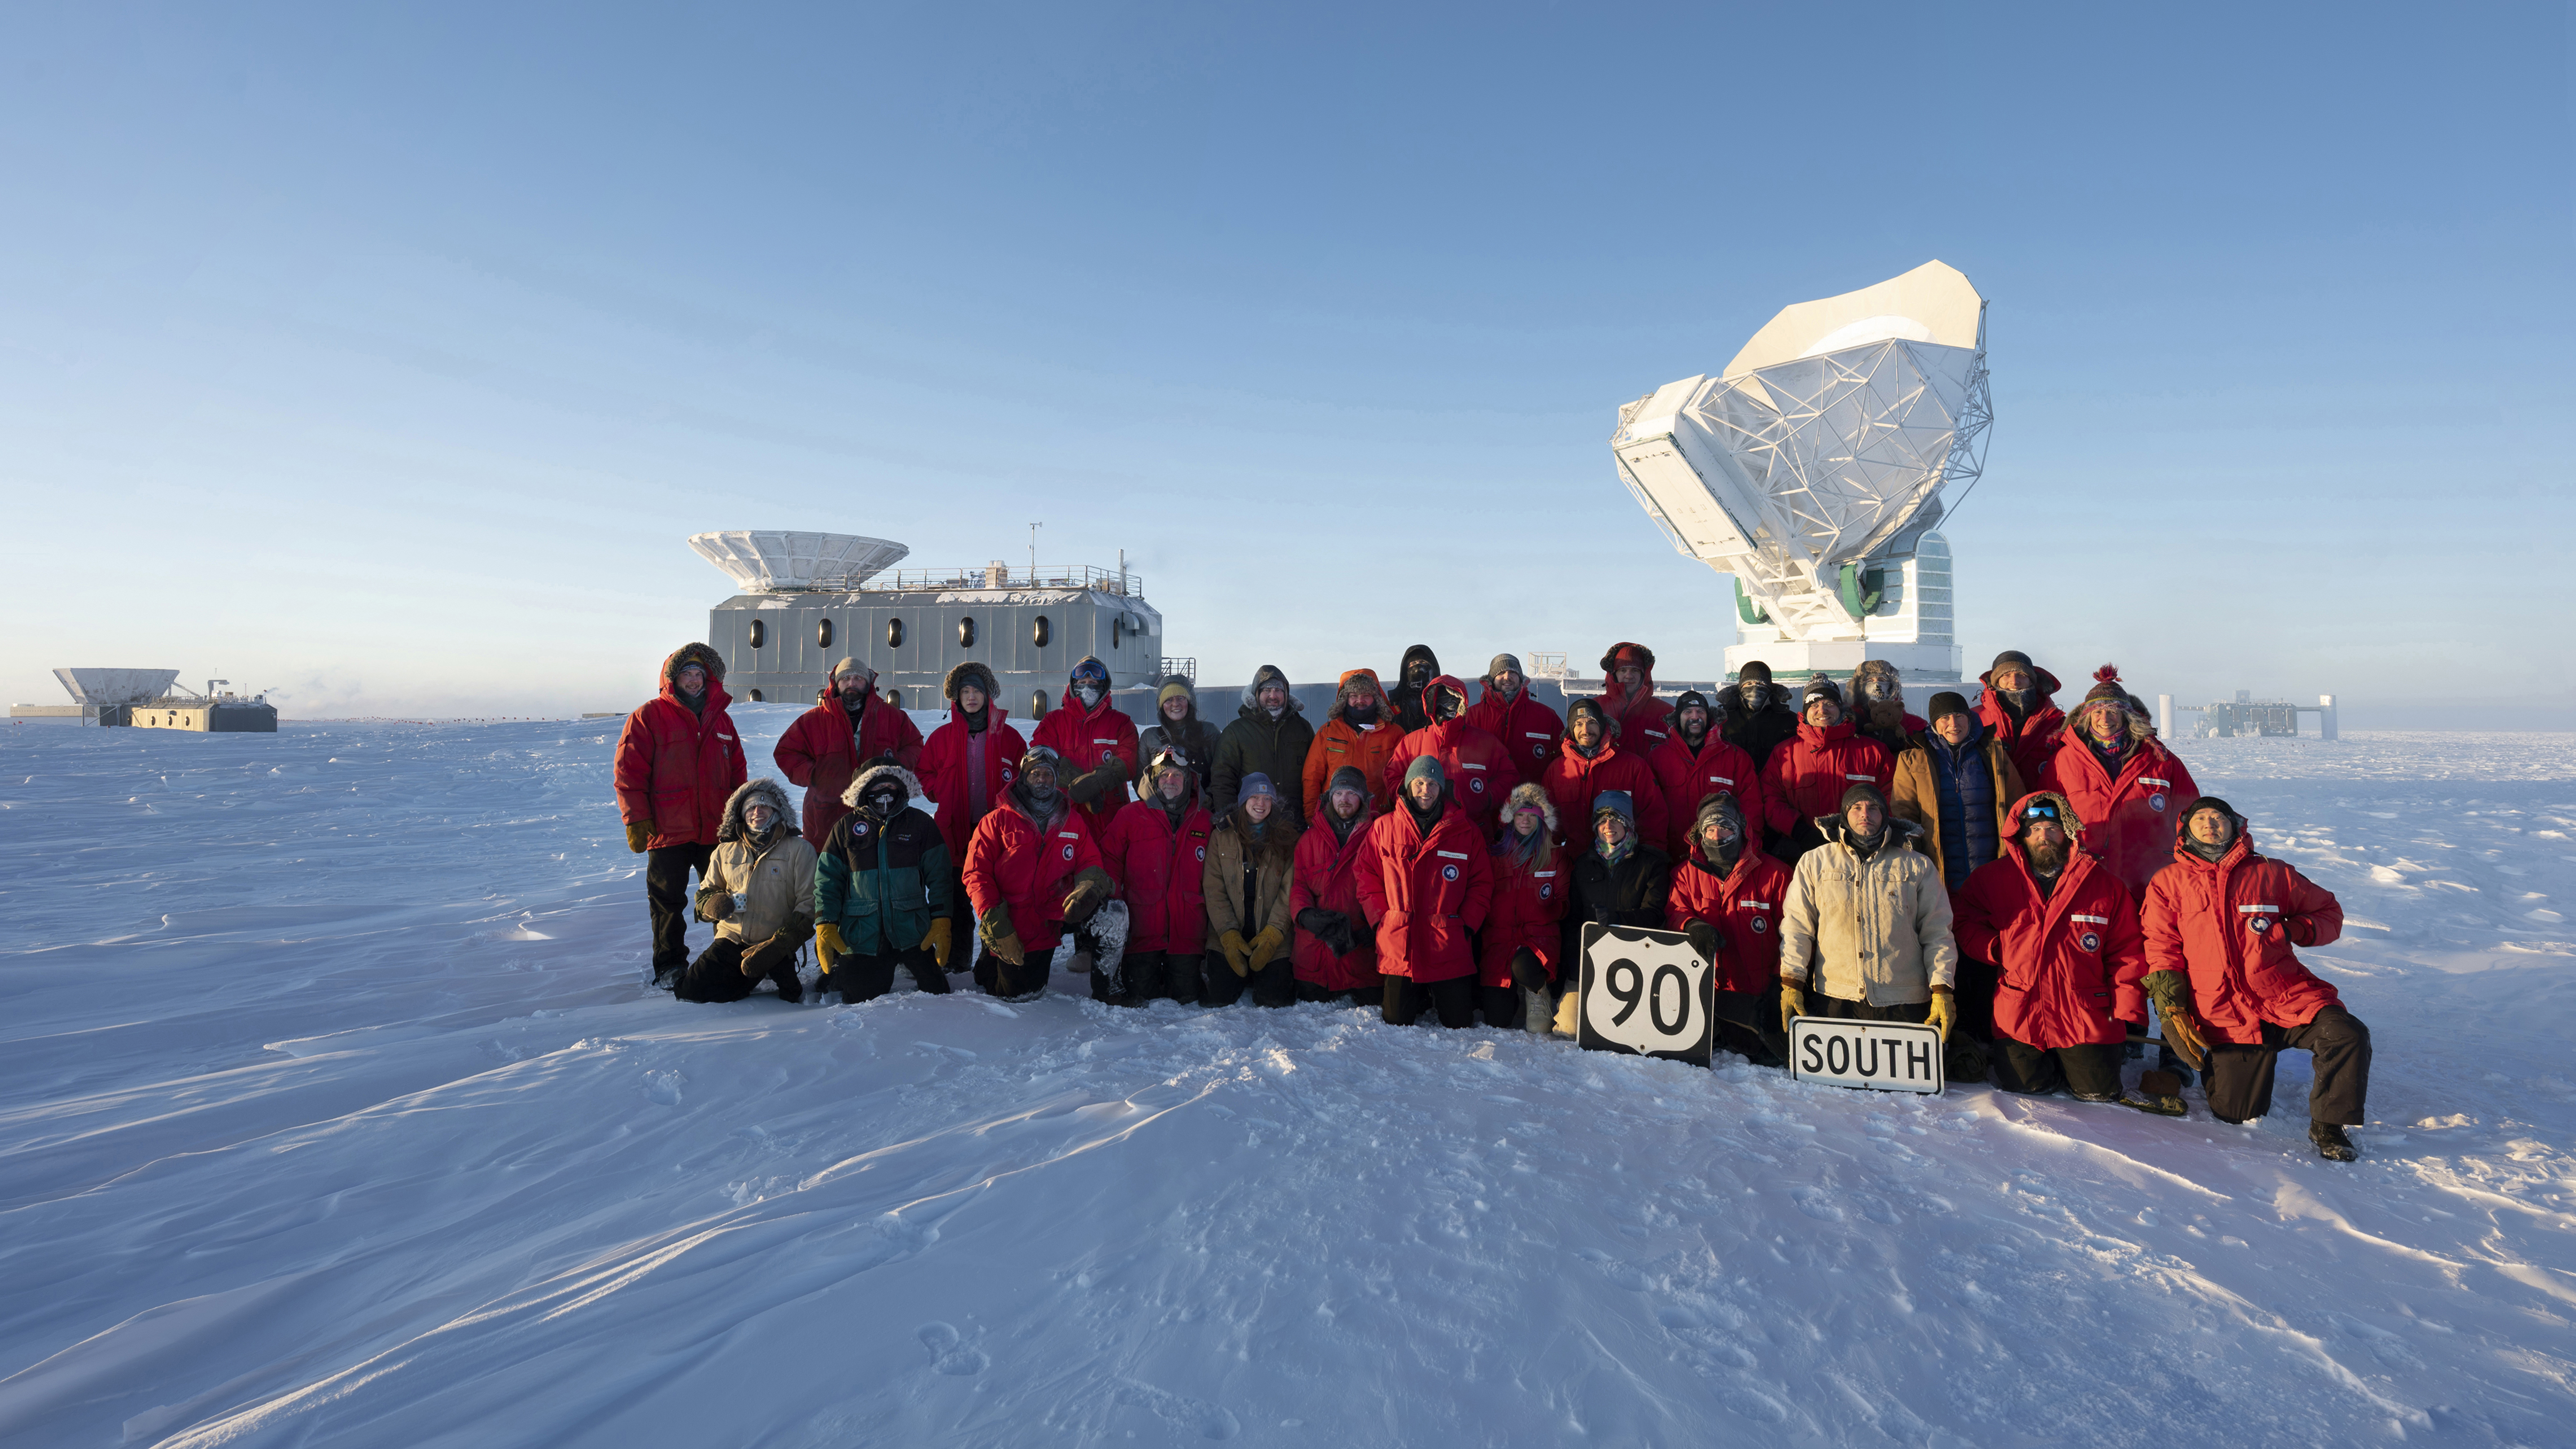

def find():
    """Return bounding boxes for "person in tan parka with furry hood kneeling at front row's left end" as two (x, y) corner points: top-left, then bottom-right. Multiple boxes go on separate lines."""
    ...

(672, 780), (814, 1001)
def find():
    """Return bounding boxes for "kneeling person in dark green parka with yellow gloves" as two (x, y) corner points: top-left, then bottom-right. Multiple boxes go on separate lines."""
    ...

(814, 759), (956, 1001)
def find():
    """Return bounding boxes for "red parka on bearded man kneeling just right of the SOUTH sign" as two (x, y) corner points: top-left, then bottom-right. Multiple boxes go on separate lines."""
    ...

(1950, 793), (2146, 1050)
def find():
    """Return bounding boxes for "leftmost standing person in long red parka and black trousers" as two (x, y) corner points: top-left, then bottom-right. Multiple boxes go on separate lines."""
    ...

(616, 644), (752, 986)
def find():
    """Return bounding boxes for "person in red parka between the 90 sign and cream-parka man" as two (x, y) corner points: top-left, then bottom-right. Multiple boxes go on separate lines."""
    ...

(1664, 790), (1790, 1066)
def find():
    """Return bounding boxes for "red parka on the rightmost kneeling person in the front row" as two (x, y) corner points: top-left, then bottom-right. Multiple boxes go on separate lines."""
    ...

(2136, 836), (2344, 1047)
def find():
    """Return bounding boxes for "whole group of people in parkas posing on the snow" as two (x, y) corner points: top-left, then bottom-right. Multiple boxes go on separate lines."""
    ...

(616, 644), (2370, 1161)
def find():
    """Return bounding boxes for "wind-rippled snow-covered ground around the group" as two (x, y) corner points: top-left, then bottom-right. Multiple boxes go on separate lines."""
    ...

(0, 705), (2576, 1449)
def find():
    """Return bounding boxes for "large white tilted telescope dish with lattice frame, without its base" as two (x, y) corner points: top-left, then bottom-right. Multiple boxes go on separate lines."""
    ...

(1610, 263), (1991, 644)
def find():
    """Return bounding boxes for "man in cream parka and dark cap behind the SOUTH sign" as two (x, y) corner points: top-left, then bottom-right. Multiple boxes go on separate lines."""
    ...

(1775, 783), (1958, 1040)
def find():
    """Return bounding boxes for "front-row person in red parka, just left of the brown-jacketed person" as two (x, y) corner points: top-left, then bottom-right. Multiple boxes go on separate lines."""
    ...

(1095, 749), (1216, 1007)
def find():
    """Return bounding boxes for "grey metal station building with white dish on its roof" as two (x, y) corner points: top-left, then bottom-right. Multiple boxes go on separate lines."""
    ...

(688, 528), (1188, 718)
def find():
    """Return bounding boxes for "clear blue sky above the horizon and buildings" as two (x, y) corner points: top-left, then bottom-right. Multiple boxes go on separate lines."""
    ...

(0, 5), (2576, 728)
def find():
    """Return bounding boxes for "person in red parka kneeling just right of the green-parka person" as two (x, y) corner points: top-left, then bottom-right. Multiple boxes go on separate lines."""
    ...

(961, 744), (1115, 996)
